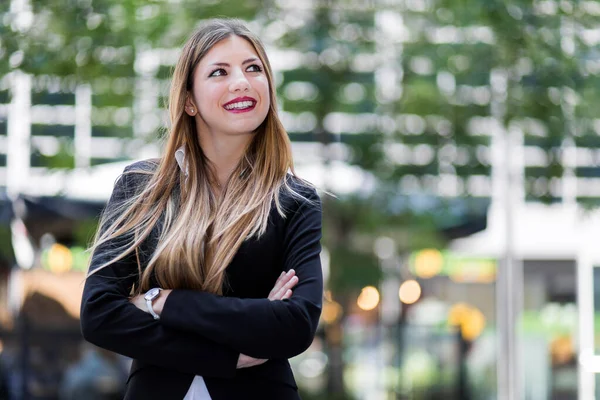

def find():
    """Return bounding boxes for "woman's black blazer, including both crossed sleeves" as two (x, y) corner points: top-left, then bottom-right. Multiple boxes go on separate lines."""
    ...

(81, 161), (323, 400)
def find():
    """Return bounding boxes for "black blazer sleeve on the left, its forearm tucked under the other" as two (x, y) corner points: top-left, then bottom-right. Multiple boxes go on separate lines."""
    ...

(81, 168), (239, 378)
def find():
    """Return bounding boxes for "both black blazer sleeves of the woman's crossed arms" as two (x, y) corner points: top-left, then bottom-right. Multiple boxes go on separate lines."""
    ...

(81, 169), (323, 377)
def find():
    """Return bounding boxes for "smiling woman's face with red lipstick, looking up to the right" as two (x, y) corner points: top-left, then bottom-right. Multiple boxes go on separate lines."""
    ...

(186, 35), (271, 141)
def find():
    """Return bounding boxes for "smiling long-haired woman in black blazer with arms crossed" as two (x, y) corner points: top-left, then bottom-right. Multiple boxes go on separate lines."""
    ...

(81, 19), (323, 400)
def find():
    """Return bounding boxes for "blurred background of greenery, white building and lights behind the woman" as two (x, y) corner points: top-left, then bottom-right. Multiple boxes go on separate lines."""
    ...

(0, 0), (600, 400)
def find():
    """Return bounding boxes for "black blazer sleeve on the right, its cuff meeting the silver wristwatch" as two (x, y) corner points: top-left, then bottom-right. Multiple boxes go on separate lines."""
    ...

(160, 189), (323, 359)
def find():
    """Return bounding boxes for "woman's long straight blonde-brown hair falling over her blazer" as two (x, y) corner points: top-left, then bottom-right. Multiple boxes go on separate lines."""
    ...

(90, 19), (299, 294)
